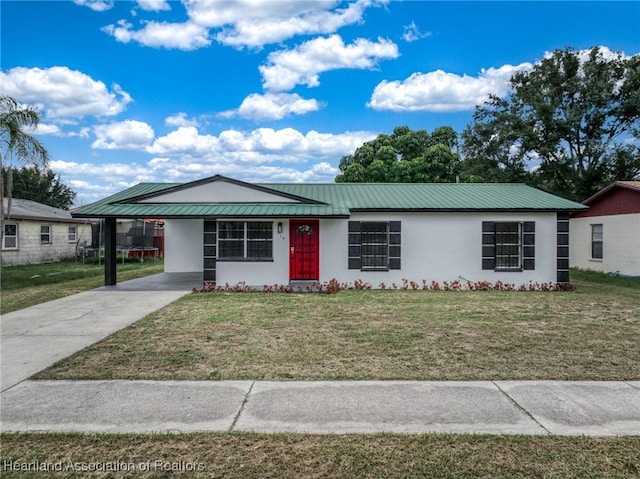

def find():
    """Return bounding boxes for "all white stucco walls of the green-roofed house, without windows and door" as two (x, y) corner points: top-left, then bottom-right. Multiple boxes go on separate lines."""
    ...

(165, 213), (557, 288)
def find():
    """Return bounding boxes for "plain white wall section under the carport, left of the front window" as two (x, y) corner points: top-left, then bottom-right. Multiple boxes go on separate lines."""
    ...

(164, 219), (204, 273)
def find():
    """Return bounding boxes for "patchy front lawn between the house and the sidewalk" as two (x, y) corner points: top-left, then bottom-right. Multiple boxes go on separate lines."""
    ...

(35, 281), (640, 380)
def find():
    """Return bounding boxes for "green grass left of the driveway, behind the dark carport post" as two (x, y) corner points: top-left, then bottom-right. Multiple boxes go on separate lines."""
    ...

(0, 258), (164, 314)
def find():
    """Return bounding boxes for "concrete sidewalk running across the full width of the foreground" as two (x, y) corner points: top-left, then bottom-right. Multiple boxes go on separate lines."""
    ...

(0, 381), (640, 436)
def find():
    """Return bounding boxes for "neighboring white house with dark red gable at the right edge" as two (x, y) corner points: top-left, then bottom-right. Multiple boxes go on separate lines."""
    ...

(570, 181), (640, 276)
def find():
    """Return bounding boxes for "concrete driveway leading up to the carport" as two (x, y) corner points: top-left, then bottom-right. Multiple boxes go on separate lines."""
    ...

(0, 273), (202, 391)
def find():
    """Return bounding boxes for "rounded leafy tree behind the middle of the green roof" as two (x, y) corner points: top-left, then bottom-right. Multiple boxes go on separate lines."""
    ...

(336, 126), (460, 183)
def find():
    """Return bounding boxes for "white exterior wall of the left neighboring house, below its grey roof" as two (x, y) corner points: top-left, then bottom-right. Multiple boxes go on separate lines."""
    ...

(2, 219), (91, 266)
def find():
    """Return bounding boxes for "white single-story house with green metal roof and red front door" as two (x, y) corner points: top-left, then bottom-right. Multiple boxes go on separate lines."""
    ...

(73, 176), (586, 288)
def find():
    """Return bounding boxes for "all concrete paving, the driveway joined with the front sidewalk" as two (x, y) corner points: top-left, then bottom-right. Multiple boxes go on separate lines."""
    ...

(0, 273), (640, 436)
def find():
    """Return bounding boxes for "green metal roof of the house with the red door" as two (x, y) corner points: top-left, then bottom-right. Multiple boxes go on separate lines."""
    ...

(73, 177), (586, 218)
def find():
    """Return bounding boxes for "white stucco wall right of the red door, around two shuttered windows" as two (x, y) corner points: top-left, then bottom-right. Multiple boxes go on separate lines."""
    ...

(320, 213), (557, 287)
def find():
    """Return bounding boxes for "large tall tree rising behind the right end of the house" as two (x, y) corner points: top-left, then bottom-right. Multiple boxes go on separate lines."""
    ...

(462, 47), (640, 200)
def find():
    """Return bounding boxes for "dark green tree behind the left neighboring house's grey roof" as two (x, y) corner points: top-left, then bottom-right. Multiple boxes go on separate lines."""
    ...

(2, 166), (76, 210)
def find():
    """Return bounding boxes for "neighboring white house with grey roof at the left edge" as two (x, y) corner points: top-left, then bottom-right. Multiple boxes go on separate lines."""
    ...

(2, 198), (91, 266)
